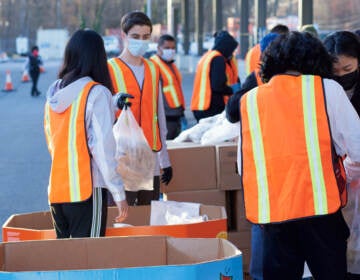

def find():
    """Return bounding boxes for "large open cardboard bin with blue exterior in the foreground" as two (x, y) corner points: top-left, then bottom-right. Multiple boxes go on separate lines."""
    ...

(0, 236), (243, 280)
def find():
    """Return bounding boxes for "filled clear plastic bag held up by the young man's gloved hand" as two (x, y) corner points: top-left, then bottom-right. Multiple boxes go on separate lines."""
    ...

(113, 108), (155, 191)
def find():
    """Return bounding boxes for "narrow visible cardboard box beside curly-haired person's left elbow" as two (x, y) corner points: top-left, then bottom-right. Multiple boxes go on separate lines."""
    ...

(216, 142), (242, 190)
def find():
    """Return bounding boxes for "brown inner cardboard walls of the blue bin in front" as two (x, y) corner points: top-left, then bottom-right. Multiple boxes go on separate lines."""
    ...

(0, 236), (240, 272)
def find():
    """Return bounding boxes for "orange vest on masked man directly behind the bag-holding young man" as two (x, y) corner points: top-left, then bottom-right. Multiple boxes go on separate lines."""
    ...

(150, 55), (185, 108)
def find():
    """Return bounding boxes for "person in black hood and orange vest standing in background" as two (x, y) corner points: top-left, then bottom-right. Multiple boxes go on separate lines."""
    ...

(190, 31), (240, 121)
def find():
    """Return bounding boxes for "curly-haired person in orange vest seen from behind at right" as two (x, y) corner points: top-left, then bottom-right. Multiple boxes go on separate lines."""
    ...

(228, 32), (360, 280)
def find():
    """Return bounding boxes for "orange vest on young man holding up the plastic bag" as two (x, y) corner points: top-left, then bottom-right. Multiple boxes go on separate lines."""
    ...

(108, 57), (162, 152)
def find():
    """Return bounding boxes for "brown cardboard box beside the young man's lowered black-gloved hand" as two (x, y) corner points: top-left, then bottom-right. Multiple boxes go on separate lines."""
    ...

(161, 142), (217, 193)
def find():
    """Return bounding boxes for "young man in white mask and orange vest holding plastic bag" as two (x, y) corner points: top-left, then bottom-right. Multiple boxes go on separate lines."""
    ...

(108, 11), (172, 205)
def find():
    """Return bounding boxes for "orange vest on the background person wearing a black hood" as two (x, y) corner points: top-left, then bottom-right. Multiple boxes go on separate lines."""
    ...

(190, 50), (238, 111)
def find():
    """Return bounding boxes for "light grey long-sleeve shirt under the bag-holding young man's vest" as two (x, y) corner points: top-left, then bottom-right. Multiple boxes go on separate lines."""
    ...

(113, 61), (171, 176)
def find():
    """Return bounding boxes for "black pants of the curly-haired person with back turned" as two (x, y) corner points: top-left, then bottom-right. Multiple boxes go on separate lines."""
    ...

(263, 211), (349, 280)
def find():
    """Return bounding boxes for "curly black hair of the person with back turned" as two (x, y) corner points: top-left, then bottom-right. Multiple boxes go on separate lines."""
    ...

(261, 31), (333, 82)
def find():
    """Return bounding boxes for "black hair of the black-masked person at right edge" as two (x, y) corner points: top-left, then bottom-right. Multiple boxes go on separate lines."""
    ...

(324, 31), (360, 63)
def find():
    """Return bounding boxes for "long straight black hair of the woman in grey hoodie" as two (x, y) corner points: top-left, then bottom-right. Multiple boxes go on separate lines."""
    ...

(59, 29), (112, 92)
